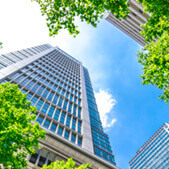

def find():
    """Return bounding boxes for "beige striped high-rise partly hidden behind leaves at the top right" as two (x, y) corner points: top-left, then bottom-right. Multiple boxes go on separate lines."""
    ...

(106, 0), (149, 46)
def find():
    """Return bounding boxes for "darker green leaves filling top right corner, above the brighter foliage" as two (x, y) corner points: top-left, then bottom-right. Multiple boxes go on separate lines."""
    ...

(137, 0), (169, 42)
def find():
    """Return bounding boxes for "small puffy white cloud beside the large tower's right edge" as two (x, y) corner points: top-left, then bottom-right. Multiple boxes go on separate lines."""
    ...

(95, 89), (117, 128)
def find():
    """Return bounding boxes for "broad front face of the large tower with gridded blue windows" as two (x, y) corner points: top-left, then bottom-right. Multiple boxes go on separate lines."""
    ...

(0, 50), (83, 147)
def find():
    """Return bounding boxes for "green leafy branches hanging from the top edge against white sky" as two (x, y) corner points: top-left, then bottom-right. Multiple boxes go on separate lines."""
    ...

(32, 0), (128, 36)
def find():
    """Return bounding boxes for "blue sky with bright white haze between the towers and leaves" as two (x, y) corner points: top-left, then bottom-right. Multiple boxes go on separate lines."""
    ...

(0, 0), (169, 169)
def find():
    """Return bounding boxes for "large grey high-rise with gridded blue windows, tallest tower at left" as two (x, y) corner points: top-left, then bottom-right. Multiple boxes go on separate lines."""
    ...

(0, 44), (118, 169)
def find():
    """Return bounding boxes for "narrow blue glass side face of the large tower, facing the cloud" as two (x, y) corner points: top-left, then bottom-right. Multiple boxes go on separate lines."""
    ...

(83, 67), (116, 165)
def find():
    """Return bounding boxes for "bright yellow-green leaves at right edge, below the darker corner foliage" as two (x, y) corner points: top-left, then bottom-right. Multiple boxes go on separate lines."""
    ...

(138, 33), (169, 103)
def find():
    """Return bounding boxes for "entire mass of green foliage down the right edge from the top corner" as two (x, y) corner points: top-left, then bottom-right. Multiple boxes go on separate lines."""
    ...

(138, 0), (169, 103)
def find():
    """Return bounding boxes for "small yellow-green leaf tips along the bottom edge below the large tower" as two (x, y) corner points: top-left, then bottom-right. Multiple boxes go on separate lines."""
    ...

(42, 158), (90, 169)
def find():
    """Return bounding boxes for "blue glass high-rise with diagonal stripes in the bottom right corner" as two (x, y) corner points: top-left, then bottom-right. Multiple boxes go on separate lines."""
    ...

(129, 123), (169, 169)
